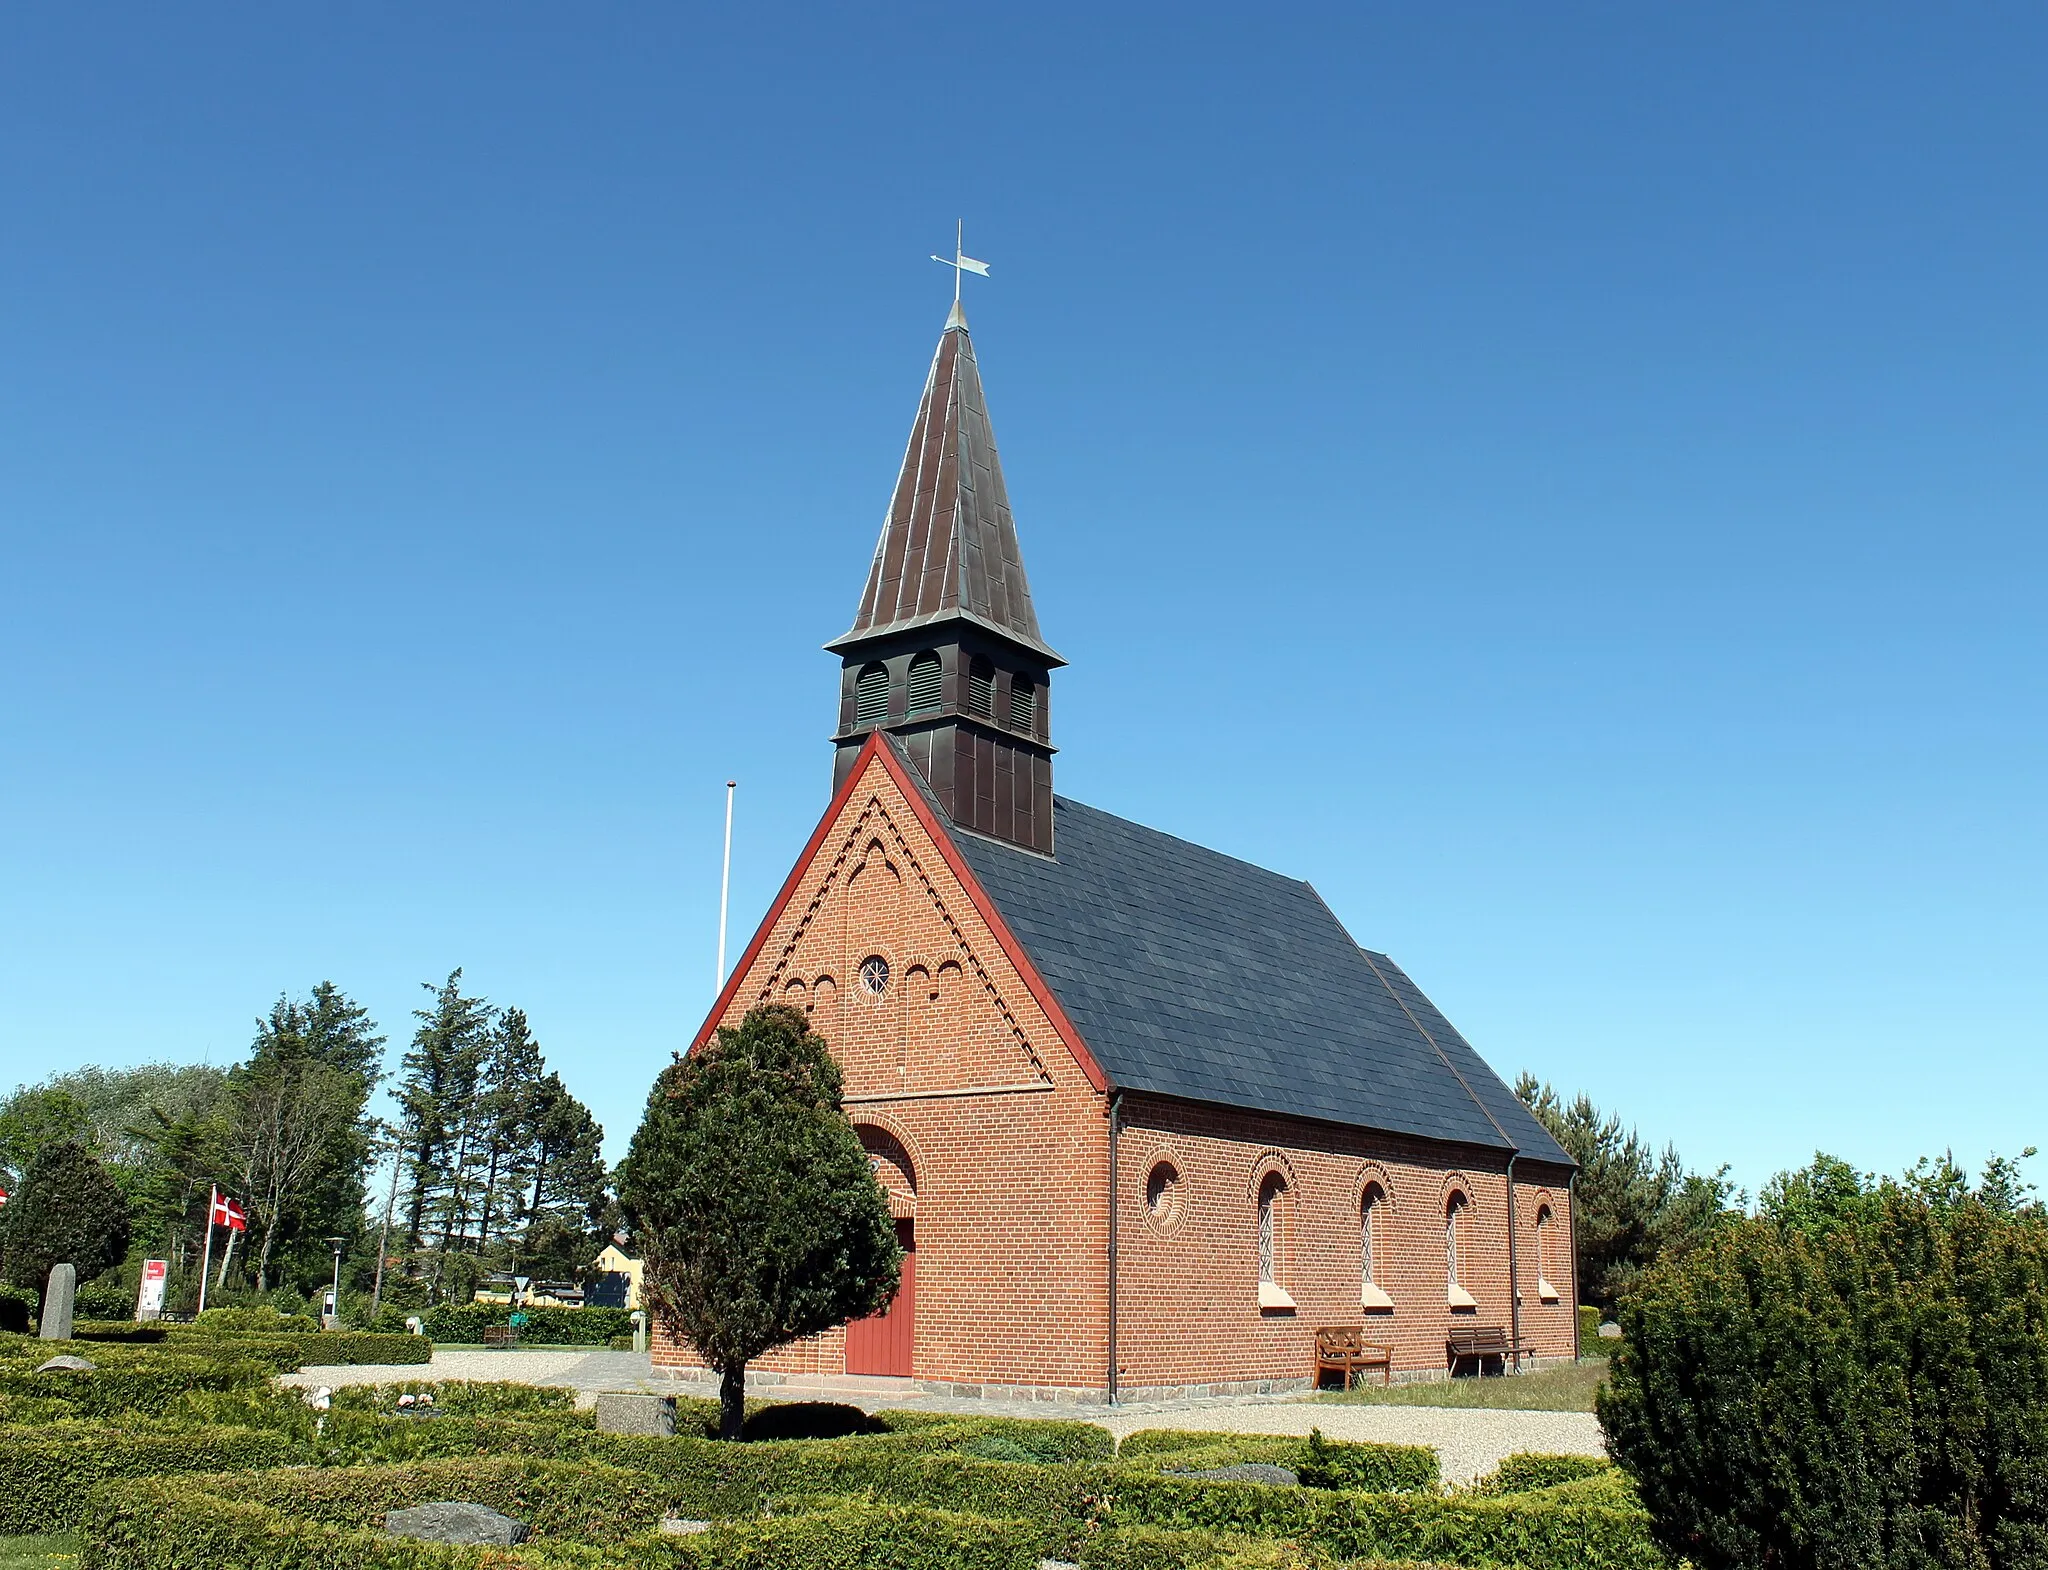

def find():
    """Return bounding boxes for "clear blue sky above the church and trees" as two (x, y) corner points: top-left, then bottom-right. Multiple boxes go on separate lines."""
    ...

(0, 4), (2048, 1185)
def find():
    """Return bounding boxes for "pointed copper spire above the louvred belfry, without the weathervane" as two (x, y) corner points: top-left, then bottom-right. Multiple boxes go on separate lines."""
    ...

(825, 301), (1065, 665)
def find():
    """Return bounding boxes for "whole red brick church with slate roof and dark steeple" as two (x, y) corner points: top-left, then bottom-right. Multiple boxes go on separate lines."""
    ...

(655, 305), (1575, 1400)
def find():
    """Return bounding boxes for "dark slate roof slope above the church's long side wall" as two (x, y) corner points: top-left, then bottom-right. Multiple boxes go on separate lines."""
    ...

(954, 796), (1571, 1167)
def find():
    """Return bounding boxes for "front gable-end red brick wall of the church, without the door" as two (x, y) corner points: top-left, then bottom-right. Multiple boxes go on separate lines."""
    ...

(655, 759), (1108, 1390)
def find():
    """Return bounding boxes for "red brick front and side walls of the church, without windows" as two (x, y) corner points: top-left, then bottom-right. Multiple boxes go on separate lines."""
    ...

(655, 757), (1575, 1390)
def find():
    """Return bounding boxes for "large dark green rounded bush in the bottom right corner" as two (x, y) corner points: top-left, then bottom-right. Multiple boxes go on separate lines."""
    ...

(1599, 1185), (2048, 1570)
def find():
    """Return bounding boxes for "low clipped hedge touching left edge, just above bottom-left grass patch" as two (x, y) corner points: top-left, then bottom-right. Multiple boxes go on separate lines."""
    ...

(0, 1423), (297, 1537)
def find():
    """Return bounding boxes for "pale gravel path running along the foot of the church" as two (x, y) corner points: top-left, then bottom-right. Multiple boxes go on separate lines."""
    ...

(283, 1347), (1606, 1482)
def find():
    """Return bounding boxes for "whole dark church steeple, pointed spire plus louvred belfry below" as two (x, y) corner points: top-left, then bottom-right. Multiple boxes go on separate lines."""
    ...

(825, 301), (1065, 854)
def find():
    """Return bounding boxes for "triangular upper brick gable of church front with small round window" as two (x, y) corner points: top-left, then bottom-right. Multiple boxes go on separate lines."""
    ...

(719, 745), (1073, 1101)
